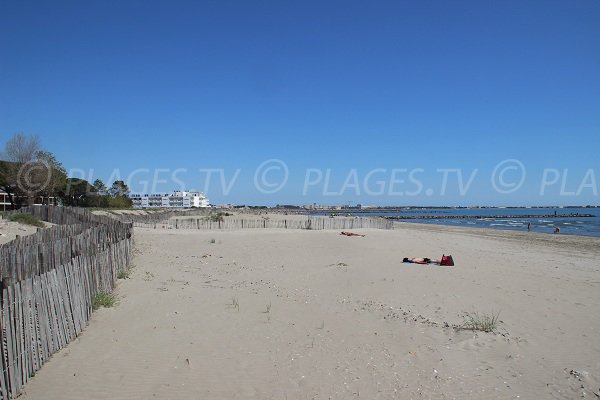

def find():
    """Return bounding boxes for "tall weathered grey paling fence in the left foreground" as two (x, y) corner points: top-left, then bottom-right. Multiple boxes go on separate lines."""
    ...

(0, 206), (133, 399)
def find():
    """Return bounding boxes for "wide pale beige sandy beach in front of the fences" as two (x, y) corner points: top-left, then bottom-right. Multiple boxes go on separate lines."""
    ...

(16, 224), (600, 399)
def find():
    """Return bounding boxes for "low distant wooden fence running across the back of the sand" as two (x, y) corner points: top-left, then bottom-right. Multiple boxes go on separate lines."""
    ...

(133, 216), (394, 230)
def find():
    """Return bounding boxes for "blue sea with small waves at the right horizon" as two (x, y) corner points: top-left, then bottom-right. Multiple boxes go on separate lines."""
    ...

(310, 207), (600, 237)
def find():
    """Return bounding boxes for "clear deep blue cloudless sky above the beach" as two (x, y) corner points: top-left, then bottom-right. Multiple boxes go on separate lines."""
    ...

(0, 0), (600, 205)
